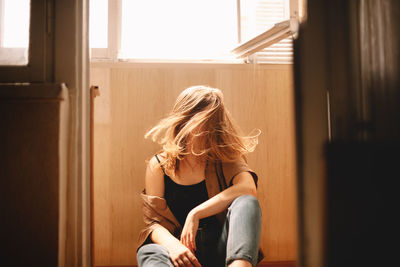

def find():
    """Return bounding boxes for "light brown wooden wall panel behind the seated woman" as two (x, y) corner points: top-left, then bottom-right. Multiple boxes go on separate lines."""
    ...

(91, 63), (297, 266)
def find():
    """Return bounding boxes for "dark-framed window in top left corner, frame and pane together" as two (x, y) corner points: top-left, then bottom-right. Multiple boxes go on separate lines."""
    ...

(0, 0), (49, 83)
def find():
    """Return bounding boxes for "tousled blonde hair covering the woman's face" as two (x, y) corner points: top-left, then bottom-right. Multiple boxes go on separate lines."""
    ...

(145, 85), (261, 174)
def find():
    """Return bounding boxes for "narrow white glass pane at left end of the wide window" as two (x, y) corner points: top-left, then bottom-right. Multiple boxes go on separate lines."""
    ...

(89, 0), (108, 48)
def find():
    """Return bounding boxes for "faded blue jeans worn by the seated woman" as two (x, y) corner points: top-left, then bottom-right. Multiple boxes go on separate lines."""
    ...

(137, 195), (261, 267)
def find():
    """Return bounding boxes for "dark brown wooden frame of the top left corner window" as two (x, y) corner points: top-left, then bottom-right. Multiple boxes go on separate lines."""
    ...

(0, 0), (53, 83)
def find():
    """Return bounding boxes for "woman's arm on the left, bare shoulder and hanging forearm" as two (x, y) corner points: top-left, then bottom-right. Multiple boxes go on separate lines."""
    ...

(145, 157), (200, 266)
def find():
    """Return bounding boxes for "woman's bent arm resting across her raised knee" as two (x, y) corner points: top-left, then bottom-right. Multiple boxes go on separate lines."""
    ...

(181, 172), (257, 251)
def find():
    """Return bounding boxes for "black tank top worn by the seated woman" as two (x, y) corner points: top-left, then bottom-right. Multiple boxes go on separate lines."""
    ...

(156, 155), (218, 227)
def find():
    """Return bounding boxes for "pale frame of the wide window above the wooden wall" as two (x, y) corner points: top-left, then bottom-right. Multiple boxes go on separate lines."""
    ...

(90, 0), (306, 64)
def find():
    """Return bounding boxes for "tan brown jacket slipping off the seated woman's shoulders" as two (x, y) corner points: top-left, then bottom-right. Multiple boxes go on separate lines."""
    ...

(138, 159), (258, 247)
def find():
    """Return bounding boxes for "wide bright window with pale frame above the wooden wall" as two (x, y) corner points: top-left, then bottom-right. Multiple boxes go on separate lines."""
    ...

(90, 0), (302, 63)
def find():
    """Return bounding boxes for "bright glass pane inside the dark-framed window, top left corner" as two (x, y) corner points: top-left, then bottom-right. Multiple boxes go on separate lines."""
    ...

(0, 0), (30, 65)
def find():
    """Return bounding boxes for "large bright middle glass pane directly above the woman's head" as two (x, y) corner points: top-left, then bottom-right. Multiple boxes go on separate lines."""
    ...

(119, 0), (237, 59)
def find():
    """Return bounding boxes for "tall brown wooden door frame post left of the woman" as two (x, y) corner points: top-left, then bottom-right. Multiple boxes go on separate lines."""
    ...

(51, 0), (91, 267)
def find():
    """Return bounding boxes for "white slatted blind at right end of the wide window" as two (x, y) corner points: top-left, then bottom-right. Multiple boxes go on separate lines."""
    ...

(241, 0), (293, 64)
